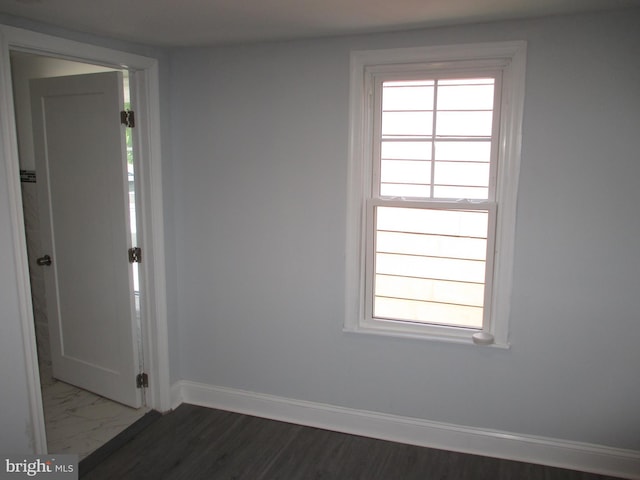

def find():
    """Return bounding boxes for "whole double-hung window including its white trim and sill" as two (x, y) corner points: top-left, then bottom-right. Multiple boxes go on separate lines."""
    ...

(345, 42), (525, 346)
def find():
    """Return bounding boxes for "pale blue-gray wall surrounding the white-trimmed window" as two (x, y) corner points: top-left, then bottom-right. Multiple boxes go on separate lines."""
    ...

(170, 10), (640, 450)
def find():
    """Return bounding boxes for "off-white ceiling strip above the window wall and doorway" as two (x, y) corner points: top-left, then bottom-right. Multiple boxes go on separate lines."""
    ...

(0, 0), (640, 46)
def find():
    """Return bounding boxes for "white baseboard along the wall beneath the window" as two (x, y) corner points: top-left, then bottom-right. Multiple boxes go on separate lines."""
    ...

(171, 381), (640, 480)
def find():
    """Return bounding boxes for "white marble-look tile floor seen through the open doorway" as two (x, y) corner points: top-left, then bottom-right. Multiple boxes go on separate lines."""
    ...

(42, 380), (148, 460)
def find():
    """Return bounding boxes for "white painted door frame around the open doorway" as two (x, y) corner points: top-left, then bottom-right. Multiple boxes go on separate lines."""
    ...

(0, 25), (171, 453)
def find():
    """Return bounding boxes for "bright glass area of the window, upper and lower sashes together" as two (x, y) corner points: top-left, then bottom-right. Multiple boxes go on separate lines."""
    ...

(372, 78), (497, 328)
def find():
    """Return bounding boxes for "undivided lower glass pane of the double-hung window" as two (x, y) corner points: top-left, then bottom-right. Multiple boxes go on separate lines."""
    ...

(373, 207), (488, 328)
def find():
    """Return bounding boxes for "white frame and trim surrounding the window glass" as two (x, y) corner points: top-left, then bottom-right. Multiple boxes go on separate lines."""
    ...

(344, 41), (526, 348)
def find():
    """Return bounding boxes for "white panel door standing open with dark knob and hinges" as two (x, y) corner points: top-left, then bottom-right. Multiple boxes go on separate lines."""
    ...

(30, 72), (142, 407)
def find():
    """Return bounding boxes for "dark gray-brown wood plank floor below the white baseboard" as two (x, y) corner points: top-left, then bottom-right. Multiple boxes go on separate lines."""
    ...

(80, 405), (624, 480)
